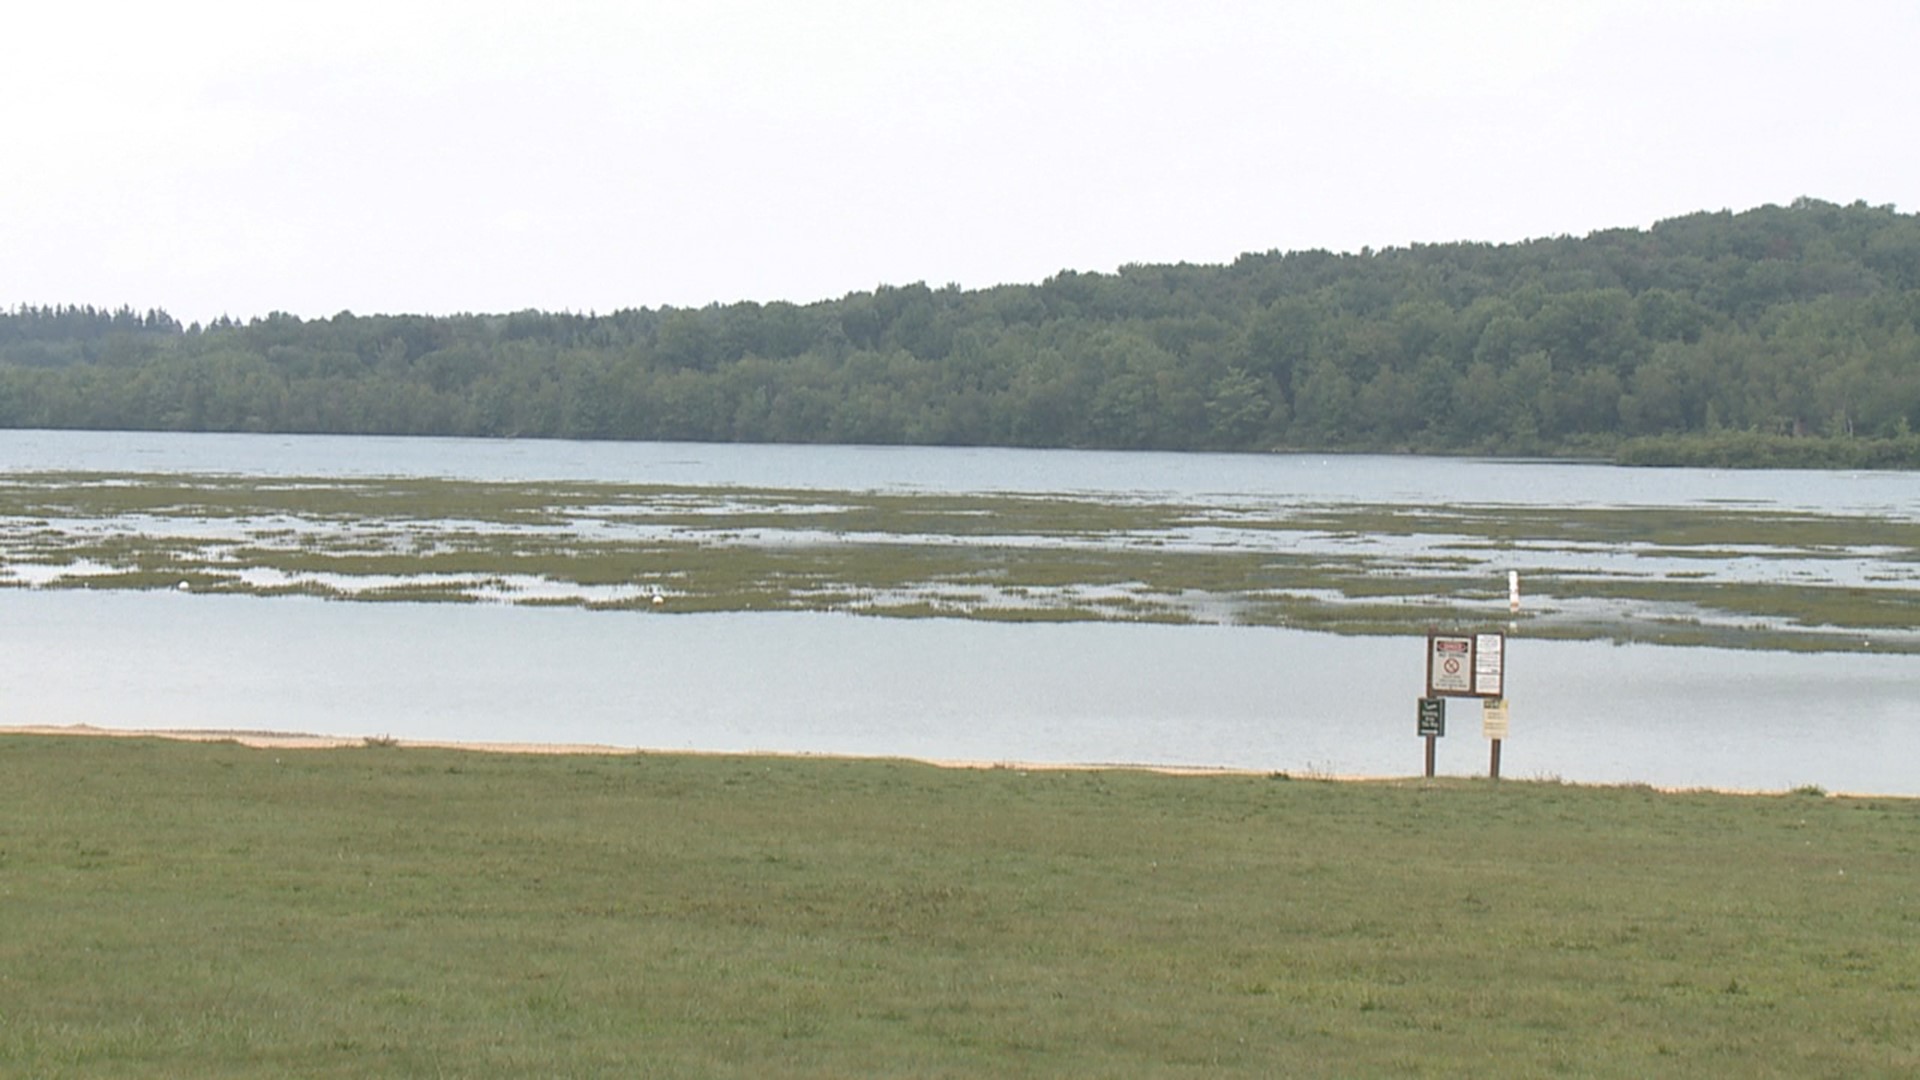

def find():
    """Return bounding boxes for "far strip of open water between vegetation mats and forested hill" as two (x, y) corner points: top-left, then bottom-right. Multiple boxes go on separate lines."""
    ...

(0, 422), (1920, 519)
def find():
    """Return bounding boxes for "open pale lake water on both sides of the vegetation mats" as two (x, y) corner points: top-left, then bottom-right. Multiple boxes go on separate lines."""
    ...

(0, 432), (1920, 796)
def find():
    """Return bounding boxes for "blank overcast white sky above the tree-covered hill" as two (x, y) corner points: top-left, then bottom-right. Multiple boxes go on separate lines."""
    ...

(0, 0), (1920, 321)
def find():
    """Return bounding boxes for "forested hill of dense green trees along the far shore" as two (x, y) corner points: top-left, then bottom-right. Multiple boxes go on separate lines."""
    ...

(0, 200), (1920, 467)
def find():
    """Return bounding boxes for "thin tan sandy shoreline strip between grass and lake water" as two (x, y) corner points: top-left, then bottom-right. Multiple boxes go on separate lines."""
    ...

(0, 724), (1920, 799)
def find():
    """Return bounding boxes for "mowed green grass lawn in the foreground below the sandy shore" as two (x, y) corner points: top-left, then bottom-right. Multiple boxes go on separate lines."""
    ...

(0, 736), (1920, 1076)
